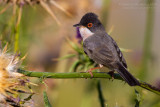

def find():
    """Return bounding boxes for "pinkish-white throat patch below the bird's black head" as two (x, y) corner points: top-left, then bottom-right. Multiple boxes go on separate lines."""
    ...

(79, 26), (94, 41)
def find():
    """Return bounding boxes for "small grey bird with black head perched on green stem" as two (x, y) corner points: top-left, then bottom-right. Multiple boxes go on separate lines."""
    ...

(73, 12), (140, 86)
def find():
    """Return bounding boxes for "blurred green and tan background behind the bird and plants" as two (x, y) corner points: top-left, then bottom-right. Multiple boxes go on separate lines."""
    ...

(0, 0), (160, 107)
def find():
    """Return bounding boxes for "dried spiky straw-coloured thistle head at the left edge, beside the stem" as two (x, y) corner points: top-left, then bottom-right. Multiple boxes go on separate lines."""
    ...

(0, 45), (33, 106)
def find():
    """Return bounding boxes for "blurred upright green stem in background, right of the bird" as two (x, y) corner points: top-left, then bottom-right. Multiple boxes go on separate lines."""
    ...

(140, 0), (154, 80)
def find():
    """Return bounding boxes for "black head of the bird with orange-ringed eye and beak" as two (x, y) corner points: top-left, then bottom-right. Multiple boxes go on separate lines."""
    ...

(73, 13), (105, 33)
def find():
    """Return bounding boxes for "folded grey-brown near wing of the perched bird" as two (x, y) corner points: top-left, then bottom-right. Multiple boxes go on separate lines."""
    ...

(83, 38), (115, 66)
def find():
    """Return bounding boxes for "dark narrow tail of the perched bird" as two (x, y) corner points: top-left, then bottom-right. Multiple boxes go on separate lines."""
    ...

(117, 64), (140, 86)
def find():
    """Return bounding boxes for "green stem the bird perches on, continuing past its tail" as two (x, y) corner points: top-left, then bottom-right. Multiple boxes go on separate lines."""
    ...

(17, 69), (160, 95)
